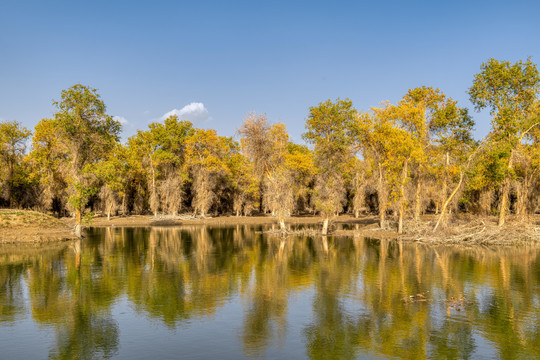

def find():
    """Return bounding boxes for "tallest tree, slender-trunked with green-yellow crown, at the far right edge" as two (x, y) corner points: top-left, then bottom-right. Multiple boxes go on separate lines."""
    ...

(469, 59), (540, 226)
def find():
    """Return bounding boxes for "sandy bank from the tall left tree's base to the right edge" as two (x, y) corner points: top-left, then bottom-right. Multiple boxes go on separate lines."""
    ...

(82, 215), (540, 246)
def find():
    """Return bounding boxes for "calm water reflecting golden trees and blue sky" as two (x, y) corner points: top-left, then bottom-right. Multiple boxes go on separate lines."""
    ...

(0, 226), (540, 359)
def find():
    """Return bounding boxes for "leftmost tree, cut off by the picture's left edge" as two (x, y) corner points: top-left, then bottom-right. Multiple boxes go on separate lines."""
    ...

(0, 121), (32, 207)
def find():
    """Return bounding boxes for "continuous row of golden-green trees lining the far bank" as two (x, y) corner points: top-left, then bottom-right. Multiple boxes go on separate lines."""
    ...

(0, 59), (540, 233)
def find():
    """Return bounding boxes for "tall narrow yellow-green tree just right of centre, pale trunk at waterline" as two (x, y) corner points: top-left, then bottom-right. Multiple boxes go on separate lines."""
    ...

(303, 99), (357, 235)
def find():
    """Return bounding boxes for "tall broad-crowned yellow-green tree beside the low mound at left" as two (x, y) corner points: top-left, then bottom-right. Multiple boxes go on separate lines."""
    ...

(34, 84), (121, 229)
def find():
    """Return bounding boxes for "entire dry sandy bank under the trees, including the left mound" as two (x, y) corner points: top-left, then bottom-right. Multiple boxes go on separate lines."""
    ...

(0, 209), (540, 246)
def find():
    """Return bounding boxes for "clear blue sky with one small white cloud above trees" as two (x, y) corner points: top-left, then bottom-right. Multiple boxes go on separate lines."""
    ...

(0, 0), (540, 142)
